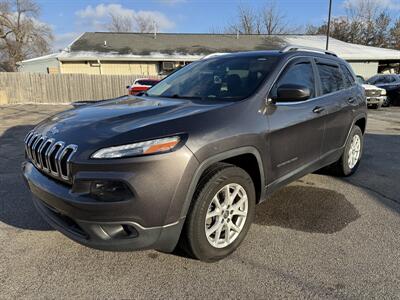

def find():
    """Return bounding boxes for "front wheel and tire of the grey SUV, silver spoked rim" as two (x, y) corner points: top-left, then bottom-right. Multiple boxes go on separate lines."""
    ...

(180, 163), (256, 262)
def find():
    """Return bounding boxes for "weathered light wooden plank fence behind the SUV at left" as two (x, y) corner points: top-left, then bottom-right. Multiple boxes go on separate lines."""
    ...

(0, 73), (162, 104)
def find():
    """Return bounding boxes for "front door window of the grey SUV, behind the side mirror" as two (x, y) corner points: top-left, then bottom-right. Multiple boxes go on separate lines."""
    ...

(271, 62), (315, 98)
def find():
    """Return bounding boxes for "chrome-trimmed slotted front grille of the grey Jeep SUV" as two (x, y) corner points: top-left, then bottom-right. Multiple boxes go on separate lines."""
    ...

(24, 131), (78, 182)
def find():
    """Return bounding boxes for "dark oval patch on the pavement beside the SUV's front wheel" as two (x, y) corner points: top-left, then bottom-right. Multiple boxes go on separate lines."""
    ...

(255, 185), (360, 233)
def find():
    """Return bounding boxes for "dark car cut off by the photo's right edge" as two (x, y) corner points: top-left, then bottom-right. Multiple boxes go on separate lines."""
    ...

(367, 74), (400, 106)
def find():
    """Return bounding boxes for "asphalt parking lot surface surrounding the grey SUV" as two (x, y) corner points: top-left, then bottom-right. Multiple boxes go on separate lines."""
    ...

(0, 105), (400, 299)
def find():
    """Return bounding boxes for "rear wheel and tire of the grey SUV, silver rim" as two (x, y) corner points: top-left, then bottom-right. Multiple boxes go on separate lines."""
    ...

(330, 125), (364, 177)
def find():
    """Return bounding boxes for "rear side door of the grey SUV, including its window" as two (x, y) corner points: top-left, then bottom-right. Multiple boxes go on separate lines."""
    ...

(315, 58), (358, 156)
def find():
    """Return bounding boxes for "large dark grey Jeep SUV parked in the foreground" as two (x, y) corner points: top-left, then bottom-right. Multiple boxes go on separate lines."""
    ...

(22, 47), (367, 261)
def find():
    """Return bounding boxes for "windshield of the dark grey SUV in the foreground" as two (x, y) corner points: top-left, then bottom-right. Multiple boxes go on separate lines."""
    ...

(147, 55), (277, 100)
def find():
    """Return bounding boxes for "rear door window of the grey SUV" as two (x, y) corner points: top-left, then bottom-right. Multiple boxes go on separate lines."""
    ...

(317, 64), (345, 94)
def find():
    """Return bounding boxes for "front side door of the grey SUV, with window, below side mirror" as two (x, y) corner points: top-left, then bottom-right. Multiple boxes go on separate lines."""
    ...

(267, 58), (324, 182)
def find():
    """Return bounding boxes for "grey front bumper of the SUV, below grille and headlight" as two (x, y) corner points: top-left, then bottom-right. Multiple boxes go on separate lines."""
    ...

(22, 145), (197, 252)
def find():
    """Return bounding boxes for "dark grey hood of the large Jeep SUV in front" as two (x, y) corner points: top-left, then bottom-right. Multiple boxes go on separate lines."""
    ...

(35, 96), (229, 146)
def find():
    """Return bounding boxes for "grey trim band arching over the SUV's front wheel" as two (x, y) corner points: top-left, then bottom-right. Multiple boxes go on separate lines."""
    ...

(180, 146), (265, 218)
